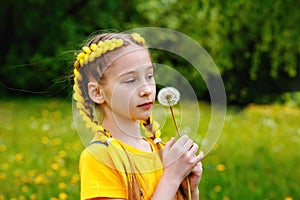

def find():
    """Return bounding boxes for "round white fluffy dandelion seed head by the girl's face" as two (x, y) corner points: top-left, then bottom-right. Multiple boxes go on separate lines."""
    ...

(157, 87), (180, 106)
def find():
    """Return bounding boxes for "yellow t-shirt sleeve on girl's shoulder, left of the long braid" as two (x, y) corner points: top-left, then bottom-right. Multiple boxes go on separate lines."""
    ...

(79, 144), (127, 200)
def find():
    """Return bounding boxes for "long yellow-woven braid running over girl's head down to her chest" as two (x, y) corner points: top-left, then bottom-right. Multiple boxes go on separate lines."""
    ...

(73, 33), (145, 200)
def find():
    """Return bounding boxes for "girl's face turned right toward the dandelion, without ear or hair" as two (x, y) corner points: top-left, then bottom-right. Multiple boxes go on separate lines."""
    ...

(101, 49), (156, 120)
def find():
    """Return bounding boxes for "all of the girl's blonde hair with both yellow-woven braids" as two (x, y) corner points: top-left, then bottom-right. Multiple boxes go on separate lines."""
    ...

(73, 33), (182, 200)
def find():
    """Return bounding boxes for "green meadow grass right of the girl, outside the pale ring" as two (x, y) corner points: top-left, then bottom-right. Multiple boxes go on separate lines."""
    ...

(200, 105), (300, 200)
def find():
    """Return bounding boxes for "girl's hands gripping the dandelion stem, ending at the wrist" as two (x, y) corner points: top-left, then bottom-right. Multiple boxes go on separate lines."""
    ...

(163, 135), (203, 183)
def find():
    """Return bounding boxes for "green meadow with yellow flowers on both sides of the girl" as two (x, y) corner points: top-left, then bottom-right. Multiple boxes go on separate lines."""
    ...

(0, 98), (300, 200)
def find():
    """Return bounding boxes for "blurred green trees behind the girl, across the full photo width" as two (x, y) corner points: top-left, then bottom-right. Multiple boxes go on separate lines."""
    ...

(0, 0), (300, 105)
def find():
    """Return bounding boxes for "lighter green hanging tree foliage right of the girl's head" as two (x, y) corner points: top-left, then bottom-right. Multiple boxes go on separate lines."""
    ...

(137, 0), (300, 104)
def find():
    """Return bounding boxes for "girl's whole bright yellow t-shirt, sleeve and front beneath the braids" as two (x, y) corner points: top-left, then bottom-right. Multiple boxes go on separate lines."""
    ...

(79, 140), (163, 200)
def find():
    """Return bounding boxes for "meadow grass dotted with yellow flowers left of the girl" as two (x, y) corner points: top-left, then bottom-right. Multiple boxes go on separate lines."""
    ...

(0, 99), (83, 200)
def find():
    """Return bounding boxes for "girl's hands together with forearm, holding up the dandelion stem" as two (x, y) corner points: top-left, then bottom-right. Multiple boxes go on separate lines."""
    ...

(152, 135), (203, 200)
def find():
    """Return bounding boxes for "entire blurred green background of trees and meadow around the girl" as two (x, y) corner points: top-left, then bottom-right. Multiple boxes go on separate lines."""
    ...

(0, 0), (300, 200)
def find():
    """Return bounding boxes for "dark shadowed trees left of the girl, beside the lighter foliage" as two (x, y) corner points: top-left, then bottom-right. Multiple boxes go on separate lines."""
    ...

(0, 0), (133, 95)
